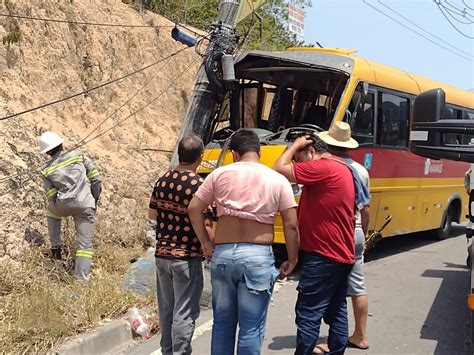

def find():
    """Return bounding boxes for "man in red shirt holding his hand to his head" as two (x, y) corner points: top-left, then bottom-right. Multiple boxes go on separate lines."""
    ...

(274, 124), (357, 355)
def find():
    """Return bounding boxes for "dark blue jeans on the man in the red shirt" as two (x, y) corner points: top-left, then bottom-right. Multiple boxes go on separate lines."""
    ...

(295, 252), (352, 355)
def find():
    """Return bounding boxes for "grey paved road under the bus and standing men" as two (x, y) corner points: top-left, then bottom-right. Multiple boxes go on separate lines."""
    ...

(129, 227), (469, 355)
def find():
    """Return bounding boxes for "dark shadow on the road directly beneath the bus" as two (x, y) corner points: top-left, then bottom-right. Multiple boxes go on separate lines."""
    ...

(365, 225), (465, 262)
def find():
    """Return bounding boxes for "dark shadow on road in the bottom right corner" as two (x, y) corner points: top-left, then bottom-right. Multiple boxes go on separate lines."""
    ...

(420, 263), (469, 354)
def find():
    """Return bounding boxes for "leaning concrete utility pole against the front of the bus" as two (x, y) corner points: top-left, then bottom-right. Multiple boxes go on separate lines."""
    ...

(170, 0), (241, 168)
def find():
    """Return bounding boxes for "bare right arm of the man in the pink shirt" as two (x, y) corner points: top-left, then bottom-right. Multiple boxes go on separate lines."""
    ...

(280, 207), (300, 278)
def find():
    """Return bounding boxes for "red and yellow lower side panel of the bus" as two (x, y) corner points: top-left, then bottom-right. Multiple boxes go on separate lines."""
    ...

(351, 147), (469, 237)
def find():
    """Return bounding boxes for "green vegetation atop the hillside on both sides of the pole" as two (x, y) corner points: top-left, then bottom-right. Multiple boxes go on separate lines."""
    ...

(142, 0), (312, 50)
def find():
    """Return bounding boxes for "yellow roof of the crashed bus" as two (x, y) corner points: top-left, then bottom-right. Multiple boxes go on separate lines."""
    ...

(280, 47), (474, 109)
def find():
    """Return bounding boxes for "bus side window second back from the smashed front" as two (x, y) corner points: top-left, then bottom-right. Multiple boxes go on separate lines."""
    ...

(377, 92), (410, 148)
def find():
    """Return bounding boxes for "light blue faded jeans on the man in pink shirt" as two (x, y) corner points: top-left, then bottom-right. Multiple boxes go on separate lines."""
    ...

(211, 243), (279, 355)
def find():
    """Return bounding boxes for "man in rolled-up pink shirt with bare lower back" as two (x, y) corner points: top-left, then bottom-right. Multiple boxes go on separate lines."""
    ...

(188, 129), (299, 355)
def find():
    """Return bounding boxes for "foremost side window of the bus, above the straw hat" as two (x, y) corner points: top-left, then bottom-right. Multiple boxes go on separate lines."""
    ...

(349, 83), (375, 145)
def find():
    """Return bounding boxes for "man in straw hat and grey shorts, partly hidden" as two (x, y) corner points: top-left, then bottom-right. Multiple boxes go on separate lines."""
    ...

(319, 122), (370, 350)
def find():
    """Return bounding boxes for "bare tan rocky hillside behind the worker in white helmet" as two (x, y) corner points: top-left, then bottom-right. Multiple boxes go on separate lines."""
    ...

(0, 0), (199, 261)
